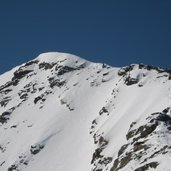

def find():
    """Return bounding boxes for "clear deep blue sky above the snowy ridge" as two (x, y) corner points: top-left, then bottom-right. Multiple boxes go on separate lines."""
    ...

(0, 0), (171, 73)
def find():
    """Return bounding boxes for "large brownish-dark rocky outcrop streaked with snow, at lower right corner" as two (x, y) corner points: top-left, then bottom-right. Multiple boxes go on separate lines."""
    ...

(111, 108), (171, 171)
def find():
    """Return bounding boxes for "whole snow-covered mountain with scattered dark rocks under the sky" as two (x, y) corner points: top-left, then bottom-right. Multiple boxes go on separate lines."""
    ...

(0, 52), (171, 171)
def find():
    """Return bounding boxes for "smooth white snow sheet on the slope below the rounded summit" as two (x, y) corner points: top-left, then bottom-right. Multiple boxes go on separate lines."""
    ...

(0, 52), (171, 171)
